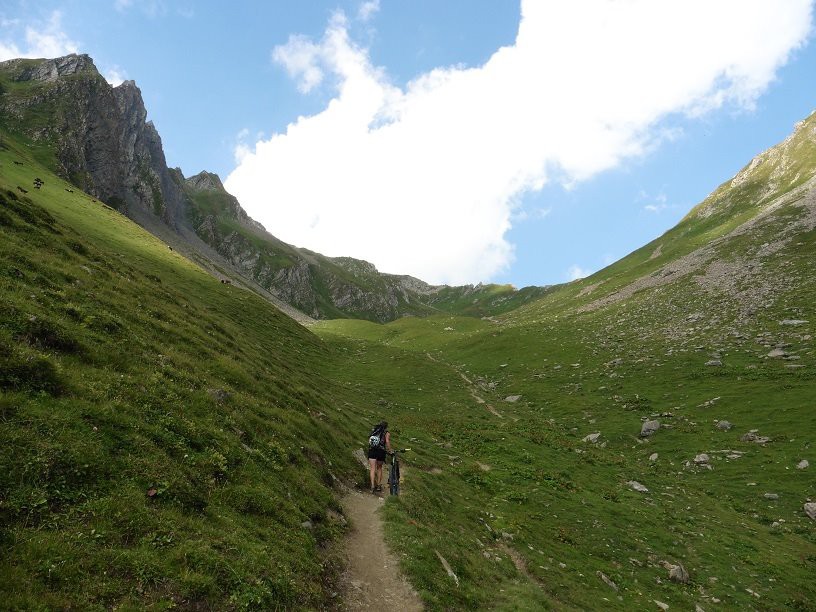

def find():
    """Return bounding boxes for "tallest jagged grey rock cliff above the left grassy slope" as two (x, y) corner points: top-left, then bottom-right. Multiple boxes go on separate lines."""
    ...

(0, 55), (184, 228)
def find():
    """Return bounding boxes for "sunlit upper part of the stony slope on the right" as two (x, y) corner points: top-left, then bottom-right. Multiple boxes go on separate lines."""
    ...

(506, 113), (816, 320)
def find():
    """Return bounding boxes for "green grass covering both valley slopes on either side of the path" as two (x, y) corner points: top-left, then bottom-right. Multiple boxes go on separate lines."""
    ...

(0, 55), (816, 610)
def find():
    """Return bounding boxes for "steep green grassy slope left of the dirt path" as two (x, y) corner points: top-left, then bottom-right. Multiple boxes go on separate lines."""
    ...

(0, 134), (370, 609)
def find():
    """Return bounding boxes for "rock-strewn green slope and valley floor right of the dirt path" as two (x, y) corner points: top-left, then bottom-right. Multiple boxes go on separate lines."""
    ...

(316, 115), (816, 610)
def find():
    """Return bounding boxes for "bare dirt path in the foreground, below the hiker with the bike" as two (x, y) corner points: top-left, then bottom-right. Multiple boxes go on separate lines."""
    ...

(340, 454), (424, 612)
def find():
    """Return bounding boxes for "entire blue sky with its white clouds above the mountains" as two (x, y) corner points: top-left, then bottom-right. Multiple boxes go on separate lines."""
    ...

(0, 0), (816, 286)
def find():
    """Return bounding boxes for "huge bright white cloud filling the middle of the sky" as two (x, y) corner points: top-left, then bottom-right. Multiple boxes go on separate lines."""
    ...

(226, 0), (812, 283)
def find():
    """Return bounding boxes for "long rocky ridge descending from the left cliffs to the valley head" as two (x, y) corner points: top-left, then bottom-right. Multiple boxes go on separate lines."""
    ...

(0, 55), (542, 322)
